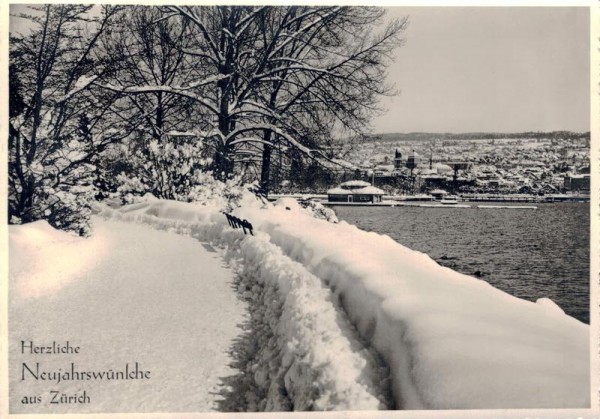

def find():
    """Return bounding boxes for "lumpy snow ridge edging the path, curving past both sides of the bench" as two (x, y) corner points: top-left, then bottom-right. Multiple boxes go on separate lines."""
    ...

(98, 201), (388, 411)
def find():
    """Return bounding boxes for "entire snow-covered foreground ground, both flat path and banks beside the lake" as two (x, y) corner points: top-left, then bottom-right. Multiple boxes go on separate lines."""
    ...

(9, 196), (590, 412)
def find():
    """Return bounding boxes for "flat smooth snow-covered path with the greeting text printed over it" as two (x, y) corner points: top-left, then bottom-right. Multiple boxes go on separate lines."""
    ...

(9, 219), (245, 413)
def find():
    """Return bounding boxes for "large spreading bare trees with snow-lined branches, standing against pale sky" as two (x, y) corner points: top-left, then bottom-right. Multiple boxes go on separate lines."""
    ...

(96, 6), (406, 189)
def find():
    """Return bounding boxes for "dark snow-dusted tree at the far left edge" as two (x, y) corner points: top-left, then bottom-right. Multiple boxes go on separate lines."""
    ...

(8, 5), (124, 234)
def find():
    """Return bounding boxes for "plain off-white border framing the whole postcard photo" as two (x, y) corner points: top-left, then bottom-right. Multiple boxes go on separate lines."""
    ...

(0, 0), (600, 419)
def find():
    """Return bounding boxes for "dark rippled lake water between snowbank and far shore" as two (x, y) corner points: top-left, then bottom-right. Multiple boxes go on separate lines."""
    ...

(332, 203), (590, 324)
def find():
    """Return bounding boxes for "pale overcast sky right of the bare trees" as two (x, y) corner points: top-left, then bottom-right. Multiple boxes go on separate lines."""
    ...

(373, 7), (590, 133)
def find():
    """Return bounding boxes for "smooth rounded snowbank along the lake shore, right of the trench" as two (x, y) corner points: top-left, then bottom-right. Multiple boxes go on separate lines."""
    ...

(238, 203), (590, 409)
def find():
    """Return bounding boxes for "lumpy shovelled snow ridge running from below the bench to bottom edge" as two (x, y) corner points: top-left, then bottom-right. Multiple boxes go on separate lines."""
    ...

(232, 235), (385, 411)
